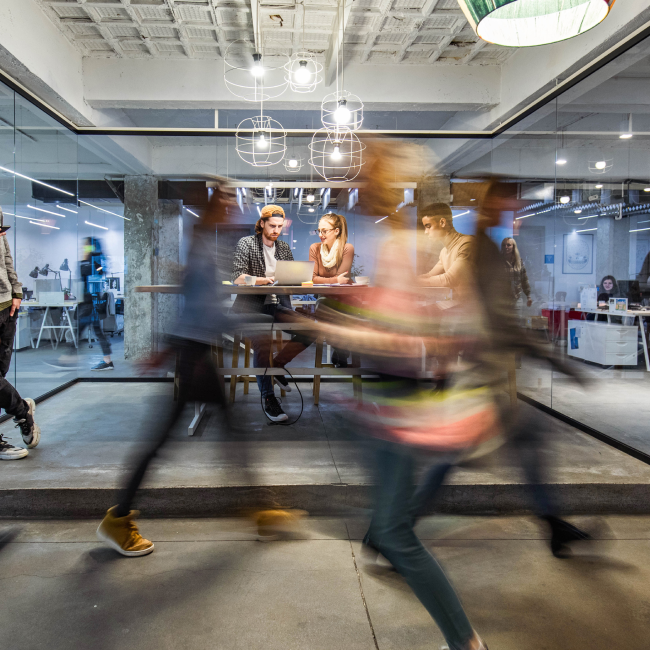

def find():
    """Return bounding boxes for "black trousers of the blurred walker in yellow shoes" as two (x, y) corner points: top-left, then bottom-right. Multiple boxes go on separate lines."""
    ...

(115, 341), (230, 517)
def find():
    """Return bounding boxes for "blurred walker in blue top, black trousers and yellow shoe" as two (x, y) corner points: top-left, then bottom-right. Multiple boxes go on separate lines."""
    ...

(97, 188), (235, 557)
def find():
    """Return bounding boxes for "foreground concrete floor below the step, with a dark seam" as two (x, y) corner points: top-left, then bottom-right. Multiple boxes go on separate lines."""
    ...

(0, 517), (650, 650)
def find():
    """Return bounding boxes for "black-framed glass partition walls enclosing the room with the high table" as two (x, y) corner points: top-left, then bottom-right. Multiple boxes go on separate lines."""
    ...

(0, 31), (650, 453)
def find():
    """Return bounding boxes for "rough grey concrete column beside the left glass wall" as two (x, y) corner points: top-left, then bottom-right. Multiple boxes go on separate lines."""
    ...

(124, 176), (158, 360)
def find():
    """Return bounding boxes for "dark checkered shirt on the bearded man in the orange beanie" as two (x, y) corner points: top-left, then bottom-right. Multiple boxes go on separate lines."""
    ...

(230, 235), (293, 312)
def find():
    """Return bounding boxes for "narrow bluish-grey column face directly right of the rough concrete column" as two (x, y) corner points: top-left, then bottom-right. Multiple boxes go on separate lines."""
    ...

(154, 200), (183, 338)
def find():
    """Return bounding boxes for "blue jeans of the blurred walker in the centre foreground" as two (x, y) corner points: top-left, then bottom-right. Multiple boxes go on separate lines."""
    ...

(367, 441), (474, 650)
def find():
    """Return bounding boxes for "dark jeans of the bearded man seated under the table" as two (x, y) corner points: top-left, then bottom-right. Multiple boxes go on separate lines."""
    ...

(251, 305), (316, 397)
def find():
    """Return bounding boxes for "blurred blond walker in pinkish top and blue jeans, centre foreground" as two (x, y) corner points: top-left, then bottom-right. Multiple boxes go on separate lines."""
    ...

(319, 142), (494, 650)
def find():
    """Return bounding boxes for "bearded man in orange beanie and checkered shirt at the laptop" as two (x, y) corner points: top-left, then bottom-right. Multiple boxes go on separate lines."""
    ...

(232, 205), (316, 422)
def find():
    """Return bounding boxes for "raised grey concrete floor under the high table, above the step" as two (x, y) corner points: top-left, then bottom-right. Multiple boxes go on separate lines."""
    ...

(0, 382), (650, 489)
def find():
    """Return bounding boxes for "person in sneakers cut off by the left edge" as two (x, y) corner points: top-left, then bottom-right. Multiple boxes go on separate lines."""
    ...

(0, 208), (41, 460)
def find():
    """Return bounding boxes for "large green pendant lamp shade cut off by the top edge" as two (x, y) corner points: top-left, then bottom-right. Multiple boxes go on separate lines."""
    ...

(458, 0), (614, 47)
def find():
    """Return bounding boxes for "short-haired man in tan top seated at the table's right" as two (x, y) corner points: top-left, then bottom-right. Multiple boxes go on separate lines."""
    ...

(419, 203), (474, 298)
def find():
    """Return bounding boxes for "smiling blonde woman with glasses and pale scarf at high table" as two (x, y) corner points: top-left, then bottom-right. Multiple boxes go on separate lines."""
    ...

(309, 212), (354, 368)
